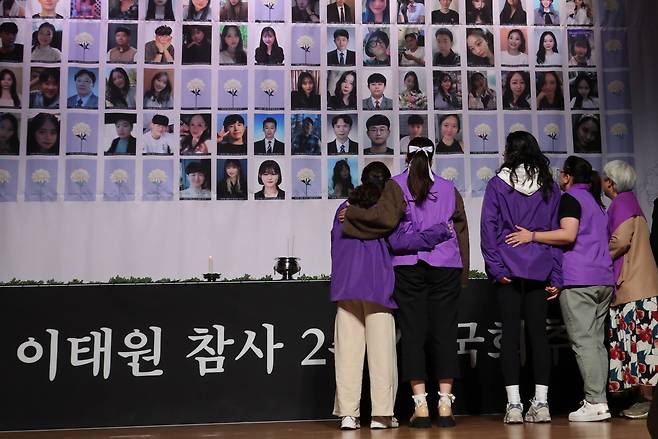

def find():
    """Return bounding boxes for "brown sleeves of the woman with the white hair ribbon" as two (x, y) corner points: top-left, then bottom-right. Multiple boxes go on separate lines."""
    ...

(343, 180), (470, 288)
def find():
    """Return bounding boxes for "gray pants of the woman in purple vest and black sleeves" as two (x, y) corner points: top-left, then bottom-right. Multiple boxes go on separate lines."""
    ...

(560, 285), (612, 404)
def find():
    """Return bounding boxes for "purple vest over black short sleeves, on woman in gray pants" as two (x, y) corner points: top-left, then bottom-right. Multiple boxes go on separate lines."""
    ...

(562, 184), (615, 286)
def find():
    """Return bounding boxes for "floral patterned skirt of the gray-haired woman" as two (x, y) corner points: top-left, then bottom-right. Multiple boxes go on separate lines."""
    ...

(608, 297), (658, 392)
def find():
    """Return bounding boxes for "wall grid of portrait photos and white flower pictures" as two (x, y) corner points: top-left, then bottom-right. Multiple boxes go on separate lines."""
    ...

(0, 0), (633, 201)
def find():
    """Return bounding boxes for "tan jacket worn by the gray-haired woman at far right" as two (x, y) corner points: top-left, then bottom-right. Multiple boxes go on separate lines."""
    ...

(609, 216), (658, 306)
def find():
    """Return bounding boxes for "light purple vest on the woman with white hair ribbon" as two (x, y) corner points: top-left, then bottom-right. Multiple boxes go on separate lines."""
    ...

(393, 170), (463, 268)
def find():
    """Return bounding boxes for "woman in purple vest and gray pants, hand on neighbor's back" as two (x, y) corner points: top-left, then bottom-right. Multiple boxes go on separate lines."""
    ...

(506, 156), (615, 422)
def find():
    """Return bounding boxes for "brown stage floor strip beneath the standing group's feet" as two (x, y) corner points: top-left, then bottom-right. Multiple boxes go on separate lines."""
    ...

(0, 416), (649, 439)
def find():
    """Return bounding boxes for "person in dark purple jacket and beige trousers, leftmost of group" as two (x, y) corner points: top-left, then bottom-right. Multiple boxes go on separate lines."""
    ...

(331, 162), (453, 430)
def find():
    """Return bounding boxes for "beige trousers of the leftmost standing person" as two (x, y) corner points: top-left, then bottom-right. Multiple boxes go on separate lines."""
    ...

(334, 300), (398, 416)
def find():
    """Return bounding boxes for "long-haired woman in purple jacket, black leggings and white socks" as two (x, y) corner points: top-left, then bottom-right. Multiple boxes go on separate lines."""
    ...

(480, 131), (562, 424)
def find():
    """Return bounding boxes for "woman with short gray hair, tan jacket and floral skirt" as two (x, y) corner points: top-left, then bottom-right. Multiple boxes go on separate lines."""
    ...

(602, 160), (658, 419)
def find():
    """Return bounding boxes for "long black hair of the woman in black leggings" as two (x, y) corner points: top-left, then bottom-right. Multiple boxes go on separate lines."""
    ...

(500, 131), (555, 201)
